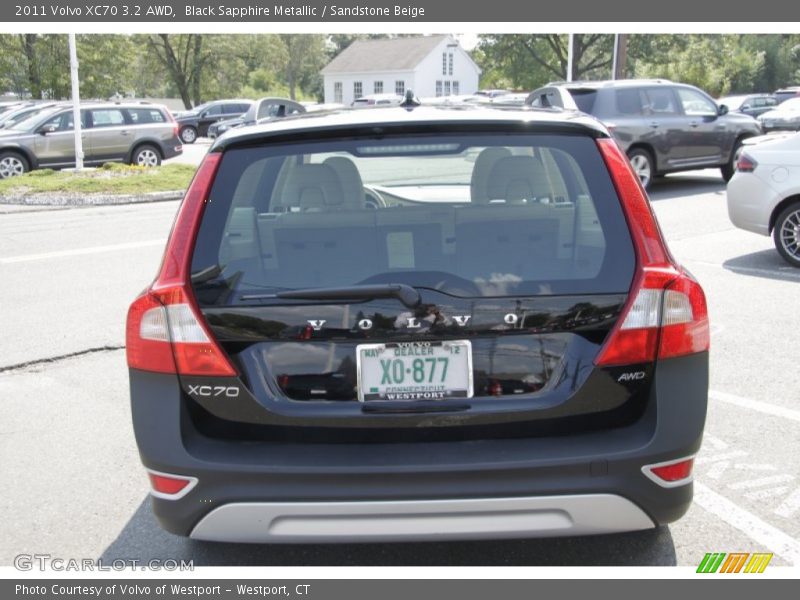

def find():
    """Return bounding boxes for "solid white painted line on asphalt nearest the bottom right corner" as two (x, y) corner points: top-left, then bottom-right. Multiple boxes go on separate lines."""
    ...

(694, 482), (800, 565)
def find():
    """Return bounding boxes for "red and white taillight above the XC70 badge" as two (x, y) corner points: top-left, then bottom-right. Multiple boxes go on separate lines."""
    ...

(125, 153), (236, 377)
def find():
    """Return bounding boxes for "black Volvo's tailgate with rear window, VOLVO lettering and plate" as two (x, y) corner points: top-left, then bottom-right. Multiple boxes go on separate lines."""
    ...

(129, 119), (707, 442)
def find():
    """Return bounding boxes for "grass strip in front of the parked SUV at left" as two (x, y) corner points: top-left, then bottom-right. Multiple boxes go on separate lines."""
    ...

(0, 163), (195, 196)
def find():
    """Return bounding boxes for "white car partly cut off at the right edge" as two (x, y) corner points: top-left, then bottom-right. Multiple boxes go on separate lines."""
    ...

(728, 134), (800, 268)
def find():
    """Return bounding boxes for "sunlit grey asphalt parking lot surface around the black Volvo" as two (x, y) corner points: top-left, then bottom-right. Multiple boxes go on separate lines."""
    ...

(0, 168), (800, 566)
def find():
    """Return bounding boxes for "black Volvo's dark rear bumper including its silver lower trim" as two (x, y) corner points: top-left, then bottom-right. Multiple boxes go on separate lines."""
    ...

(131, 354), (708, 542)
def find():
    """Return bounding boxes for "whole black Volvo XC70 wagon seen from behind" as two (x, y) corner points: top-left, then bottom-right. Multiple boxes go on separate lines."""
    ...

(126, 102), (709, 542)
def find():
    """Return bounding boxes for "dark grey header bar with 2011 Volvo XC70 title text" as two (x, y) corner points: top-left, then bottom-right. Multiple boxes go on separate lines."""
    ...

(0, 0), (800, 24)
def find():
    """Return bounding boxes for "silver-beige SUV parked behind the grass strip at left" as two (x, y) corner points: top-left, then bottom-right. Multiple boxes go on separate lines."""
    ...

(0, 102), (183, 179)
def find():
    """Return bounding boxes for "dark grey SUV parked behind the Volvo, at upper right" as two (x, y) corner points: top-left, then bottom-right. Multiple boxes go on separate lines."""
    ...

(527, 79), (762, 188)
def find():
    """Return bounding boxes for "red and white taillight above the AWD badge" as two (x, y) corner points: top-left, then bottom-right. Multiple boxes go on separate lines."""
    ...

(595, 138), (710, 366)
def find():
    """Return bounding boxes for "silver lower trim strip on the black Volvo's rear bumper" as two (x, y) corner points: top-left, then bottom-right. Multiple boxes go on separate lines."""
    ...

(191, 494), (655, 543)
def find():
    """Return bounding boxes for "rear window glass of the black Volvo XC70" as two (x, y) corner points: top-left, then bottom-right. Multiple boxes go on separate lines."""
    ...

(192, 129), (635, 305)
